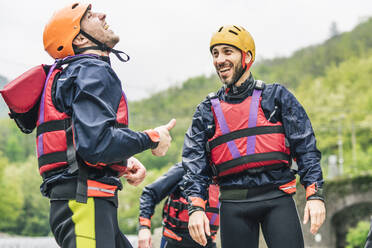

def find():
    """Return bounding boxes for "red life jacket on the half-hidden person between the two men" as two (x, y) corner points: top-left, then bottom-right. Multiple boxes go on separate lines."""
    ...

(163, 184), (220, 241)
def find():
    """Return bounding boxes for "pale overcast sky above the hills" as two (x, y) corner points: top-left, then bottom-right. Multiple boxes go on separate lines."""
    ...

(0, 0), (372, 100)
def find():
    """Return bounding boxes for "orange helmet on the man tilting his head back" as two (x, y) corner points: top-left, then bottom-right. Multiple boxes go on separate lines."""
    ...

(43, 3), (91, 59)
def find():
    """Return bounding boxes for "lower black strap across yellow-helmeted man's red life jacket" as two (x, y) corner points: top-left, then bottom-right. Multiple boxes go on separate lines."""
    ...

(215, 152), (290, 175)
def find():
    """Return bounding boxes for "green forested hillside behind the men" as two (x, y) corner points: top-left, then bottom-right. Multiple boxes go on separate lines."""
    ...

(0, 17), (372, 235)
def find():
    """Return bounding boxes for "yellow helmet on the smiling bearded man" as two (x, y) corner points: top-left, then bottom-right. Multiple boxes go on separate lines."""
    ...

(209, 25), (256, 62)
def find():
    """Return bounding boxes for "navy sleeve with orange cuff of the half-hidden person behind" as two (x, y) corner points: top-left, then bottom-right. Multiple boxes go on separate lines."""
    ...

(139, 163), (185, 227)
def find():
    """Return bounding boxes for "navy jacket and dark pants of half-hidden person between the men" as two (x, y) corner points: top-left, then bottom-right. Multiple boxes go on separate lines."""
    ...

(140, 163), (217, 248)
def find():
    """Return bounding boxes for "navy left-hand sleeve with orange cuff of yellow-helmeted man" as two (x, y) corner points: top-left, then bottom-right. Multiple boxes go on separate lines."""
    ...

(182, 100), (214, 208)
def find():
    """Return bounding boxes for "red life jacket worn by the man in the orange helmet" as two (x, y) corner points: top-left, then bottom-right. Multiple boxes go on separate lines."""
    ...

(36, 55), (128, 202)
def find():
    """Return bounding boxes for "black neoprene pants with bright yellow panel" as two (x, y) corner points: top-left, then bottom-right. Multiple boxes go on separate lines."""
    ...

(49, 197), (132, 248)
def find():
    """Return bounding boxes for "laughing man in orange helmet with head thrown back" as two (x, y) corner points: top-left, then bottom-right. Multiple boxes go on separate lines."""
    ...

(37, 3), (175, 248)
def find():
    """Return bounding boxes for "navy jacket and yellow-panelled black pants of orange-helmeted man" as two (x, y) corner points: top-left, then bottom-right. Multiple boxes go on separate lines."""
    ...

(43, 56), (157, 248)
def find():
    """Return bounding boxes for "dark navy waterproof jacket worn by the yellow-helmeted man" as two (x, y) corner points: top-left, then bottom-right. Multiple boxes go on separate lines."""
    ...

(182, 75), (323, 202)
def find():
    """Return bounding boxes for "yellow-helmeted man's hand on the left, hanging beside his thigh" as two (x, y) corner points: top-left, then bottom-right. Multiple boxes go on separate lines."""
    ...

(189, 211), (211, 246)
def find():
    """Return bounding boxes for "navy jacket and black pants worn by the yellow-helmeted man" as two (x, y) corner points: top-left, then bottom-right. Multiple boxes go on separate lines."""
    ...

(182, 75), (323, 248)
